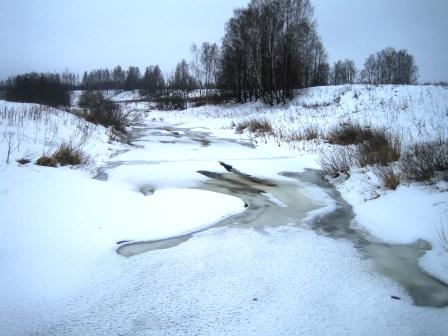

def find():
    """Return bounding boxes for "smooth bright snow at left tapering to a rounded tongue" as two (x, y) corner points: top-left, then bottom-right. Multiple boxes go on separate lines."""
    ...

(0, 167), (244, 324)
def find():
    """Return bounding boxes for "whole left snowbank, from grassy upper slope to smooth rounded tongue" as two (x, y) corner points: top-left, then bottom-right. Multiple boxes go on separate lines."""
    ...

(0, 101), (244, 324)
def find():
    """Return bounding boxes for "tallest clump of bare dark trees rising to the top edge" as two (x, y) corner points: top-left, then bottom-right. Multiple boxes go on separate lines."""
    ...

(219, 0), (329, 105)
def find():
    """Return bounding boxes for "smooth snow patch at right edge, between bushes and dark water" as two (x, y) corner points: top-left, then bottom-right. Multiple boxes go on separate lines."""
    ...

(338, 171), (448, 283)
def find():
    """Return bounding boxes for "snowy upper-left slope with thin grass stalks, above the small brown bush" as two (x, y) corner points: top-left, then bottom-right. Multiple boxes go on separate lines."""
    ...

(0, 100), (123, 167)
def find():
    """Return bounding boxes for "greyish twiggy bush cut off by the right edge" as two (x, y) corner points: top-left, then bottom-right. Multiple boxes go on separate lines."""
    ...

(401, 139), (448, 182)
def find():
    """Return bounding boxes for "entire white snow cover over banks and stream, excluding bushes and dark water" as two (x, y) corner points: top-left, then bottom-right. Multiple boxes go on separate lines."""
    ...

(0, 86), (448, 335)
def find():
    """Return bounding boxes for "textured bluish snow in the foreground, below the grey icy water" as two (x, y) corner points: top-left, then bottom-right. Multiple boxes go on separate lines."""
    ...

(8, 227), (447, 335)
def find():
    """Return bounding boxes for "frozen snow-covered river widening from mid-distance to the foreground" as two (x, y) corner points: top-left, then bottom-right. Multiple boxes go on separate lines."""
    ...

(11, 121), (448, 335)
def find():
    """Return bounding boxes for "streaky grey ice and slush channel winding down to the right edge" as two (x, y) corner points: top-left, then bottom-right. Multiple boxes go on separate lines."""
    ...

(107, 125), (448, 307)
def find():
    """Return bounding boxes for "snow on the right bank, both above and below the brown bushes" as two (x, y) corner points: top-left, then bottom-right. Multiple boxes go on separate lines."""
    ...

(147, 85), (448, 283)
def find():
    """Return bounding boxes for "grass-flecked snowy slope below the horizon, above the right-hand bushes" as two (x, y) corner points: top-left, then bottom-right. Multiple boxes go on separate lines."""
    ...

(149, 85), (448, 147)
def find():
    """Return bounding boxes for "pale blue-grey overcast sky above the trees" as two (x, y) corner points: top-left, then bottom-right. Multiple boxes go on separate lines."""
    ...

(0, 0), (448, 82)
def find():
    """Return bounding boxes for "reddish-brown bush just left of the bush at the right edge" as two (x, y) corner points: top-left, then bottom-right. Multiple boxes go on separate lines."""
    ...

(358, 130), (401, 167)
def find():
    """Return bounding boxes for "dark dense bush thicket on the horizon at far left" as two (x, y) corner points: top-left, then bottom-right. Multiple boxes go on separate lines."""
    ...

(5, 72), (70, 106)
